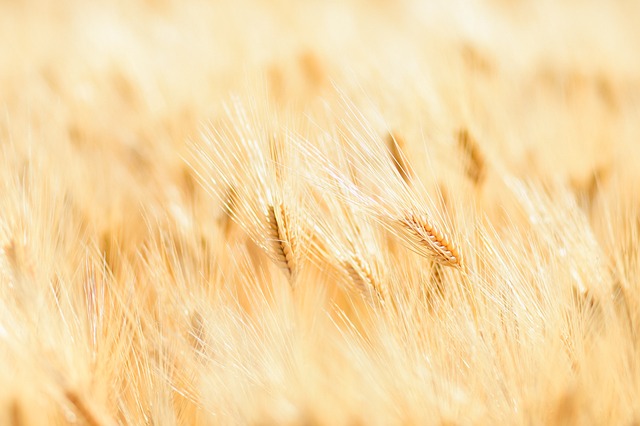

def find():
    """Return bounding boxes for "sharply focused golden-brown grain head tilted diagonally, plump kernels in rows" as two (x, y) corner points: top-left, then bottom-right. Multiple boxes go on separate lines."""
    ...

(399, 213), (462, 267)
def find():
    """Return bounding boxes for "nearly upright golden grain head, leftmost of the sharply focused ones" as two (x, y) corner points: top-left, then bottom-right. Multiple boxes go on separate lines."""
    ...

(267, 203), (295, 278)
